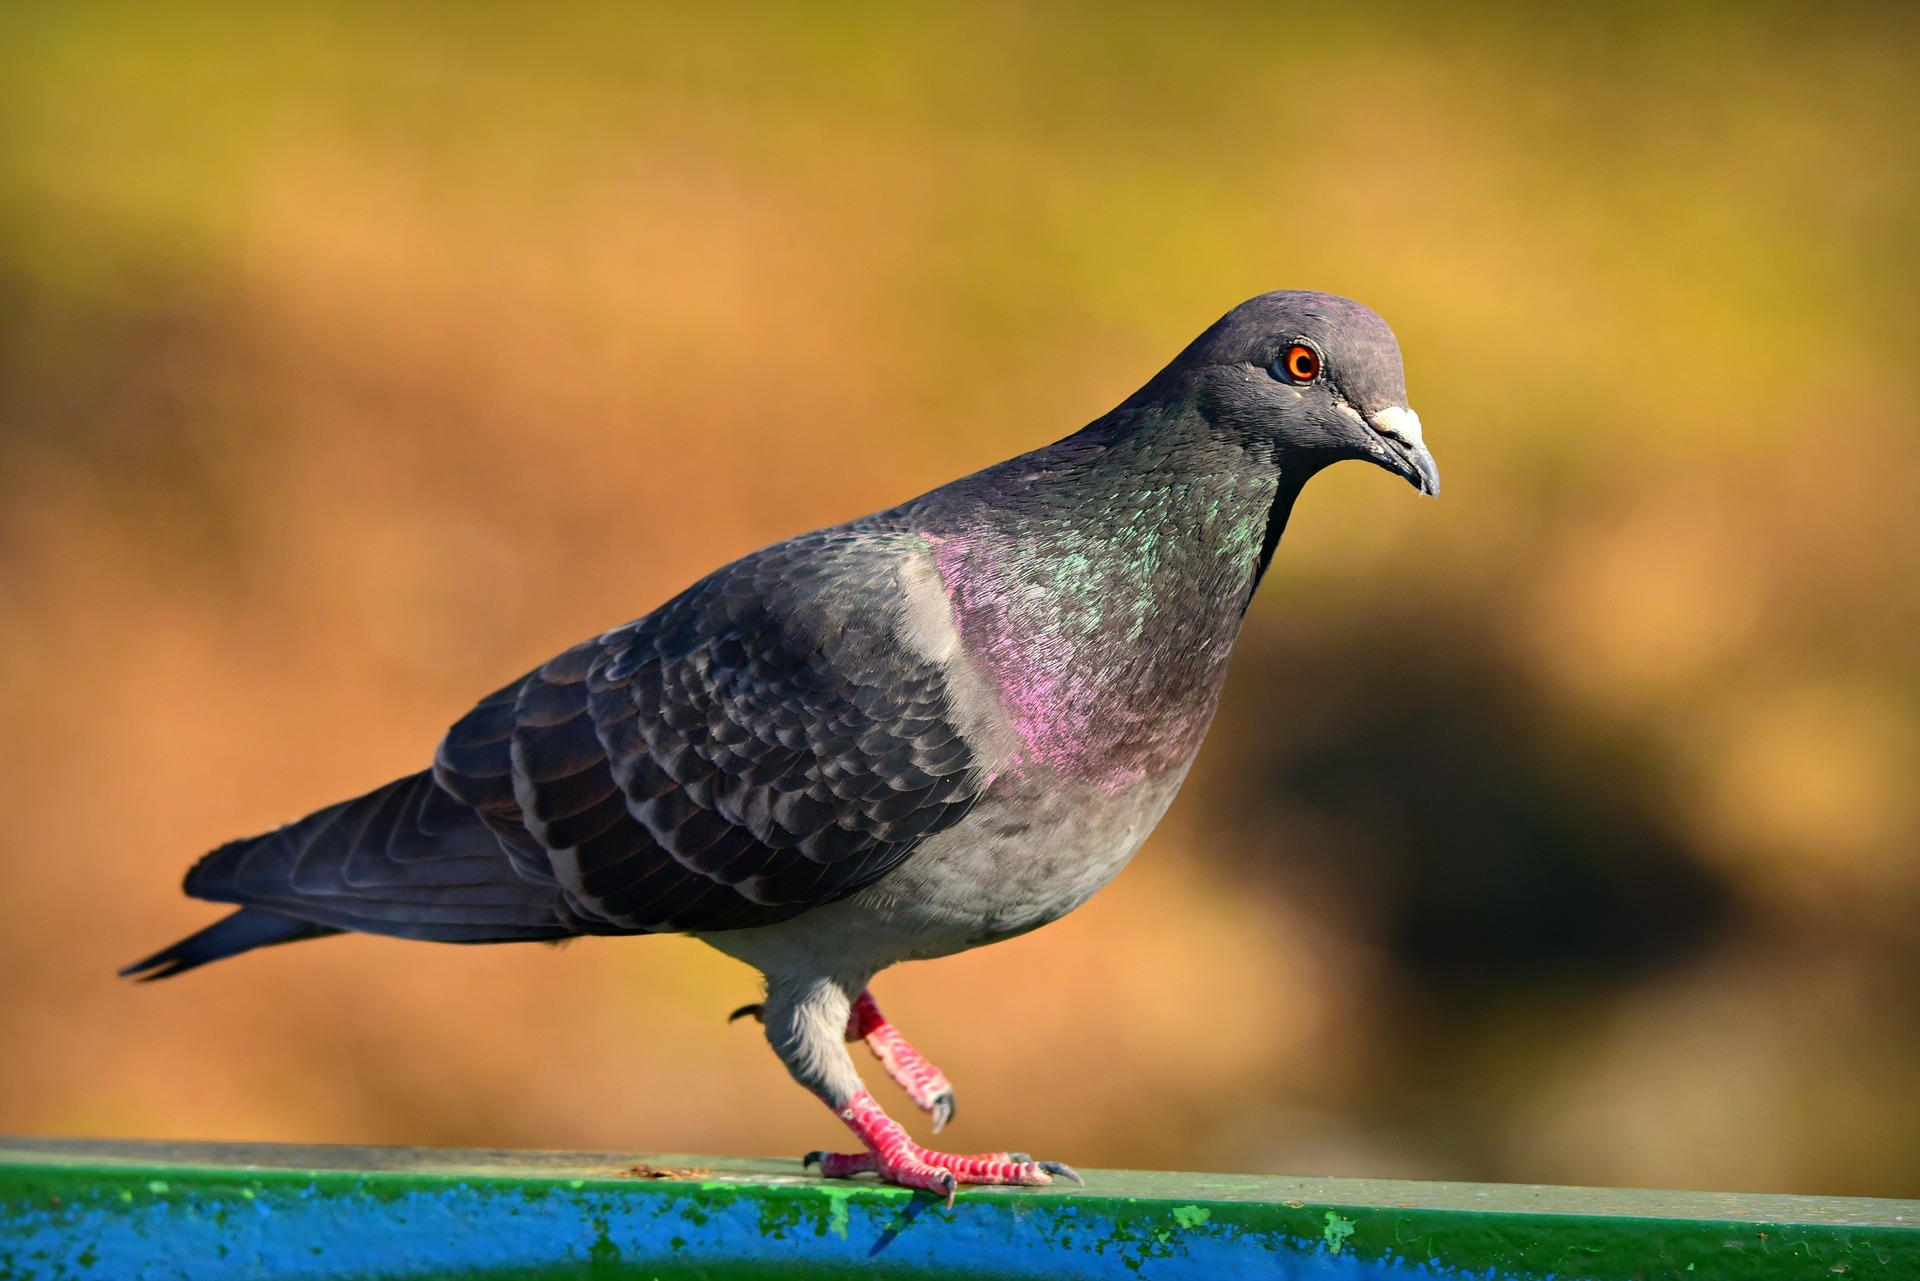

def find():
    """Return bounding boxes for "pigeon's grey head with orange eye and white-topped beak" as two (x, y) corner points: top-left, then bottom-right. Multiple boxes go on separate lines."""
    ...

(1140, 290), (1440, 494)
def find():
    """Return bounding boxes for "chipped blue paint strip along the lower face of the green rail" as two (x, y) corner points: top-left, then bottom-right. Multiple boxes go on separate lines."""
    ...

(0, 1177), (1463, 1281)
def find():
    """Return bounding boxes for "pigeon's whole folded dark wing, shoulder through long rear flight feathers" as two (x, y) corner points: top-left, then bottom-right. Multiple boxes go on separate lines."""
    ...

(188, 528), (991, 941)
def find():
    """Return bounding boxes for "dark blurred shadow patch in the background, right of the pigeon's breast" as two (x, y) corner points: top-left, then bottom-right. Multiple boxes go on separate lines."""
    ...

(1213, 611), (1730, 1008)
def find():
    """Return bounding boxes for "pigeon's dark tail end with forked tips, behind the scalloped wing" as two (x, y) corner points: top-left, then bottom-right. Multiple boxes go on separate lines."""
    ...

(121, 772), (578, 979)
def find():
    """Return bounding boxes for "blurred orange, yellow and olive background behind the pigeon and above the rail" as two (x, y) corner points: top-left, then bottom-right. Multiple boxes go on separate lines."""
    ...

(0, 4), (1920, 1196)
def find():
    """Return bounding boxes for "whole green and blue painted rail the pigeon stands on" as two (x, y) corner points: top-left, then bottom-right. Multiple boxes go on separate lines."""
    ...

(0, 1139), (1920, 1281)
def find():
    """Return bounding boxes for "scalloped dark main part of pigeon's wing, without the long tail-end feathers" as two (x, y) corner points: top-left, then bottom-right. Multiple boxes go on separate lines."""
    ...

(434, 526), (991, 933)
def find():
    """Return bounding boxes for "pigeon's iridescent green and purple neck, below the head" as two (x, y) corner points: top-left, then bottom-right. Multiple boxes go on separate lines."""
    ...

(914, 415), (1304, 789)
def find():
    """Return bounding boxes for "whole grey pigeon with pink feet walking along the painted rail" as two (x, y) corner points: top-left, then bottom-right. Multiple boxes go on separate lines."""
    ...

(123, 290), (1440, 1202)
